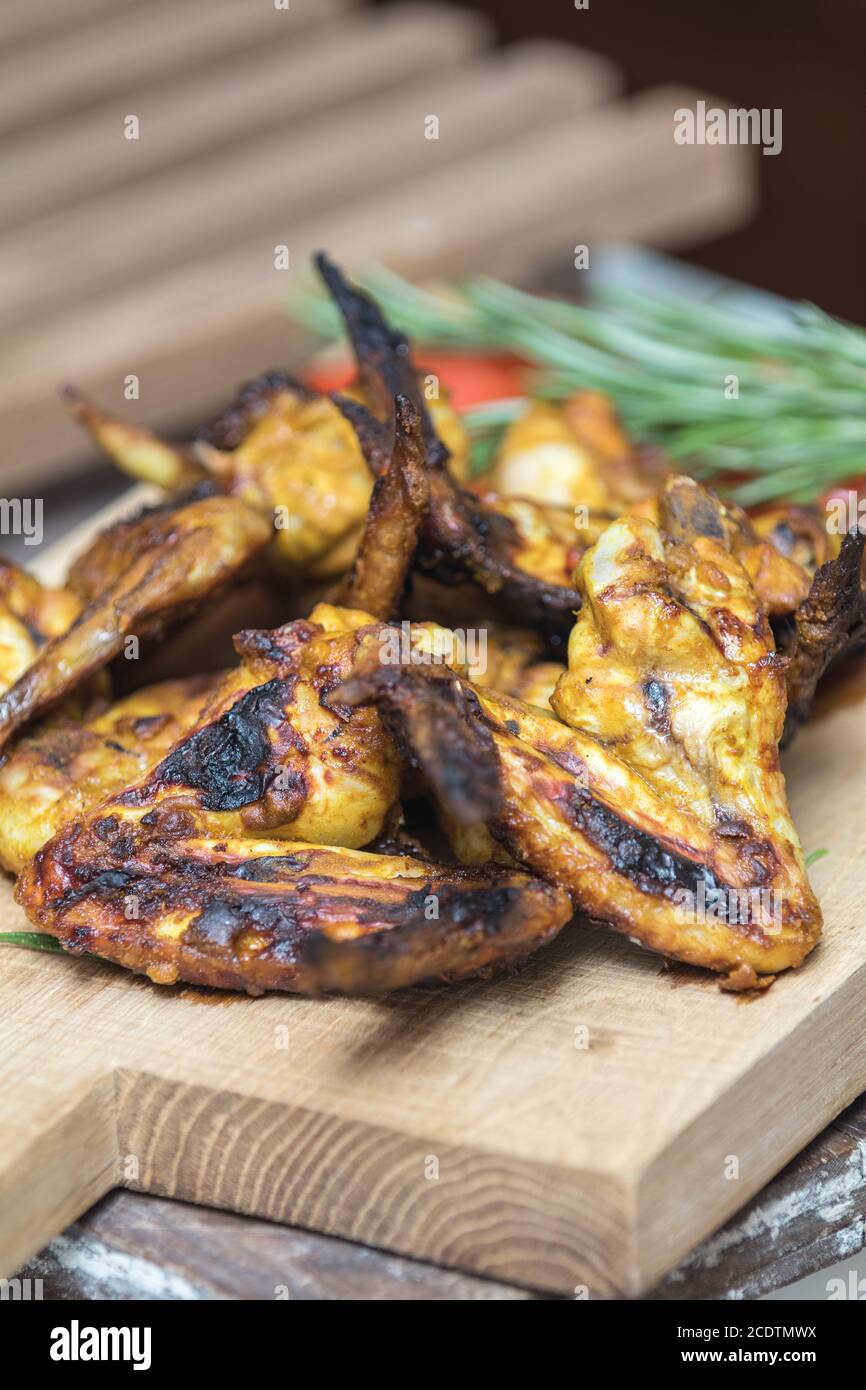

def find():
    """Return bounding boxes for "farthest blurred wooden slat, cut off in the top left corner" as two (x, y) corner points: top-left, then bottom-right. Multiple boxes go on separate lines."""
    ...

(0, 0), (352, 133)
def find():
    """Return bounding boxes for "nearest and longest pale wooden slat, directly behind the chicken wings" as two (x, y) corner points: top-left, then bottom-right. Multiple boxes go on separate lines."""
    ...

(0, 89), (753, 487)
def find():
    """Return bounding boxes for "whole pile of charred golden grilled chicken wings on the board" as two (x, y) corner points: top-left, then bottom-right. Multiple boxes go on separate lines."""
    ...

(0, 256), (865, 994)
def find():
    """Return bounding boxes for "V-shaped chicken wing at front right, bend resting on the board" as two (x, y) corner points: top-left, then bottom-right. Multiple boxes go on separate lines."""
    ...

(332, 489), (822, 984)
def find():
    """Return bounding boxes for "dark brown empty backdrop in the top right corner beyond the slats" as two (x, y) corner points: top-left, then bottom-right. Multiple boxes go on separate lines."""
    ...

(450, 0), (866, 324)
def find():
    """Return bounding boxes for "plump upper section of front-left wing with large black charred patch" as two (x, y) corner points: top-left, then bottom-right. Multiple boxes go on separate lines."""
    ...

(38, 605), (400, 848)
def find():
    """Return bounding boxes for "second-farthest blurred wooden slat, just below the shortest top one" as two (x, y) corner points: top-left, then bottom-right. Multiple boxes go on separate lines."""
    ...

(0, 4), (494, 227)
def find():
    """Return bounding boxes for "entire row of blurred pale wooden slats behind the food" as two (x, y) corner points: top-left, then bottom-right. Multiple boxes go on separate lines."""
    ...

(0, 0), (755, 491)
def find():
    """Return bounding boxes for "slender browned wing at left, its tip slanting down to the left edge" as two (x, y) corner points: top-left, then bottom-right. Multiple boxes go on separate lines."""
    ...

(0, 489), (272, 748)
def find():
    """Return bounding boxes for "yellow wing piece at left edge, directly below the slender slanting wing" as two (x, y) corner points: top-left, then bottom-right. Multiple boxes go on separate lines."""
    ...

(0, 676), (218, 873)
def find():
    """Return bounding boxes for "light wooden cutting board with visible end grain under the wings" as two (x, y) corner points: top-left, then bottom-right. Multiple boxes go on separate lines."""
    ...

(0, 514), (866, 1297)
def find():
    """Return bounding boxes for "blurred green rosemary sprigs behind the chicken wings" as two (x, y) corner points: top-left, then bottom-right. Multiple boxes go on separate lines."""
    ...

(292, 267), (866, 505)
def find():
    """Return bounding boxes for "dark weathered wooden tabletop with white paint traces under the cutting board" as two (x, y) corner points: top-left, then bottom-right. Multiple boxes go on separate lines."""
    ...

(19, 1095), (866, 1302)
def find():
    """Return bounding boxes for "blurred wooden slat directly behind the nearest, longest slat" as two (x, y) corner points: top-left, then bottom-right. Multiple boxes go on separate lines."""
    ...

(0, 44), (622, 329)
